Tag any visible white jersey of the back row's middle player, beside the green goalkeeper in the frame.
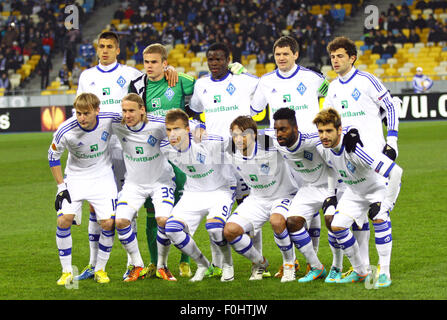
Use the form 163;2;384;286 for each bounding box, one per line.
190;72;259;137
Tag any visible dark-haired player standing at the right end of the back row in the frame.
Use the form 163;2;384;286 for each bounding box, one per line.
323;37;399;276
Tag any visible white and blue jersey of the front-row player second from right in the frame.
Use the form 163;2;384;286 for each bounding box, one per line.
265;129;330;187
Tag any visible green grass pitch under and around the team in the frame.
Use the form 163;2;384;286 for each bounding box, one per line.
0;122;447;301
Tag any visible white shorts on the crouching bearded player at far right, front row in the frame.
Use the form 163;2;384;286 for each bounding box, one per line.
332;188;388;228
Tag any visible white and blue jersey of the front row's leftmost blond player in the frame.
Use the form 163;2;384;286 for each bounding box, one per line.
48;112;119;178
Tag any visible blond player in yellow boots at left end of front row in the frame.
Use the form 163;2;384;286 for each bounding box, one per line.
48;93;118;285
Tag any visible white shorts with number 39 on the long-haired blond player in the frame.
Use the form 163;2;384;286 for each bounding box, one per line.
116;177;175;221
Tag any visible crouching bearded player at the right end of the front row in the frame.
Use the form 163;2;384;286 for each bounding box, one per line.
313;108;402;288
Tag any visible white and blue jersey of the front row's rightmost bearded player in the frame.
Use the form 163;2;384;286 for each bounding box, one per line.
319;136;396;202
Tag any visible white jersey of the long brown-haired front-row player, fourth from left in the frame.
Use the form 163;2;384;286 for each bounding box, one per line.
226;134;297;198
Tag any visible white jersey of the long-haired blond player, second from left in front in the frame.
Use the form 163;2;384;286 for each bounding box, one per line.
113;115;174;185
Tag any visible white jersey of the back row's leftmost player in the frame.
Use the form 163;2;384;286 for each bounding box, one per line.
77;62;142;113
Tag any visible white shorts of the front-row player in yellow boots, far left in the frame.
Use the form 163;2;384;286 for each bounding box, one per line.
57;170;117;225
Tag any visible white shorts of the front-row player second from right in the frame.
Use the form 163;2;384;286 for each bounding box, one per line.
287;186;331;226
